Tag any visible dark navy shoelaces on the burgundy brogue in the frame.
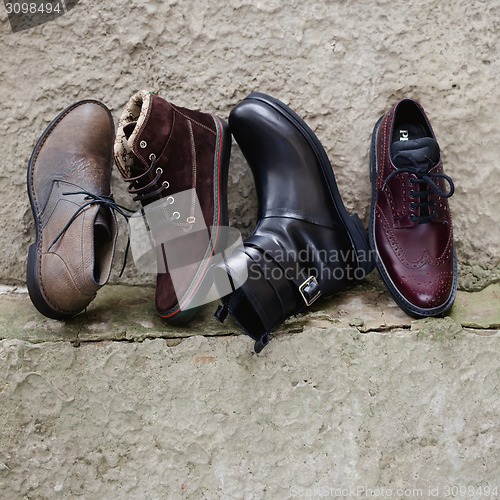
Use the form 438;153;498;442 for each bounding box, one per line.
382;152;455;224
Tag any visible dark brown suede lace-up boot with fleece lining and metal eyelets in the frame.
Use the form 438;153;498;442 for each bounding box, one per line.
114;91;231;324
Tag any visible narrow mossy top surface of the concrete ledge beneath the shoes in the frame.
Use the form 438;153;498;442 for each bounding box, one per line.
0;278;500;344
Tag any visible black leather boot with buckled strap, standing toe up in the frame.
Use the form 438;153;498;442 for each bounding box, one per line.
214;93;374;352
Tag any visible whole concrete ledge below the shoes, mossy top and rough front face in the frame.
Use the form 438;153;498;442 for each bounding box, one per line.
0;279;500;500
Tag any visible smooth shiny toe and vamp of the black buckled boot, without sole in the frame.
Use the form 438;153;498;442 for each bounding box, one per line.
229;94;338;223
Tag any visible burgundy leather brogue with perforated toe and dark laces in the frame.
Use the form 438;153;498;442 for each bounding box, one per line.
369;99;457;317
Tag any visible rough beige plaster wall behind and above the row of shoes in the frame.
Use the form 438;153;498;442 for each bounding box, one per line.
0;0;500;288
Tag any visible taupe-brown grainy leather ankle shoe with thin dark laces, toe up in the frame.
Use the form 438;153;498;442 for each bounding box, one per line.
27;100;117;319
